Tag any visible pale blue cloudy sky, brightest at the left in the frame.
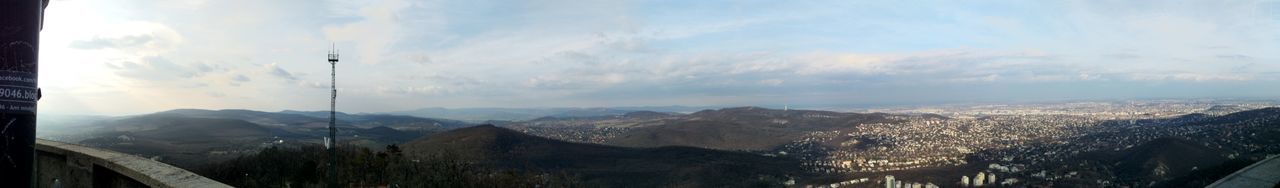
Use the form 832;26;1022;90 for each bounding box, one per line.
38;0;1280;115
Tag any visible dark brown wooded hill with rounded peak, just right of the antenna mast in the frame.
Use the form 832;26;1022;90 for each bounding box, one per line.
403;125;801;187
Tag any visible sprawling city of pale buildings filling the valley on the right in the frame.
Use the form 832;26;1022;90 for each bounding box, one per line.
783;102;1280;187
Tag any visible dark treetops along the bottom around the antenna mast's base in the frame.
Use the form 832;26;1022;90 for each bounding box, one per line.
193;145;582;188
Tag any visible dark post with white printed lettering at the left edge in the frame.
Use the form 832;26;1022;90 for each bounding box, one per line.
0;0;49;187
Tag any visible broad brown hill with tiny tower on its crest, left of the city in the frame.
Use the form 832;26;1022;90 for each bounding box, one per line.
605;107;893;151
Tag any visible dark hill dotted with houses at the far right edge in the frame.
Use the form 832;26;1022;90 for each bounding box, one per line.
1079;107;1280;187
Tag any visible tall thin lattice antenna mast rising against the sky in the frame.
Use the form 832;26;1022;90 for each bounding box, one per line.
325;45;338;188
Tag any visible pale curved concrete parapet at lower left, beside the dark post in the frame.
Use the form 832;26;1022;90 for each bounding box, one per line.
36;139;230;188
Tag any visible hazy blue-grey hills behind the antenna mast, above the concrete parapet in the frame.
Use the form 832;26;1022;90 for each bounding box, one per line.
59;109;473;168
